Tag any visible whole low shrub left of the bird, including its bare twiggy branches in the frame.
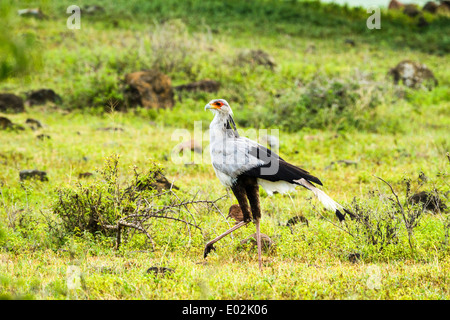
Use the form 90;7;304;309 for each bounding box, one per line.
52;156;212;249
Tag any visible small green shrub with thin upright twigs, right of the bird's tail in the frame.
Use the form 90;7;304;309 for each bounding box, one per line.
344;173;449;257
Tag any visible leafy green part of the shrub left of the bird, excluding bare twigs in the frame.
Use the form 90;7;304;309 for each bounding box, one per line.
52;156;161;236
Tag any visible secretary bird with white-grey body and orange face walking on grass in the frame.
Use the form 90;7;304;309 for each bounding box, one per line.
204;99;352;270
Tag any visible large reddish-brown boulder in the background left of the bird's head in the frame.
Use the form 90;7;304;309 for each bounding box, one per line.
124;70;175;109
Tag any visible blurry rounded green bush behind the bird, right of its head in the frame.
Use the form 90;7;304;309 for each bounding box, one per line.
243;79;382;131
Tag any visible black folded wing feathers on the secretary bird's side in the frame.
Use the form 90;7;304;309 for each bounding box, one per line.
242;145;322;185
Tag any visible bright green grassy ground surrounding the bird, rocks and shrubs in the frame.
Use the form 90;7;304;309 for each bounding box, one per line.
0;1;450;299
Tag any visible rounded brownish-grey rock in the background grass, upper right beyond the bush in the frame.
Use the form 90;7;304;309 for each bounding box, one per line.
388;60;438;90
